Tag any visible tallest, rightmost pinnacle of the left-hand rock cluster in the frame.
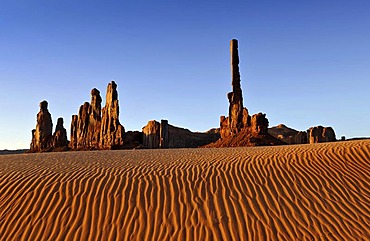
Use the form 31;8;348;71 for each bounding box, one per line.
99;81;125;149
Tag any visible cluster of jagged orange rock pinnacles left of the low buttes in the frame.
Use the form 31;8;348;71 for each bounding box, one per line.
30;81;125;152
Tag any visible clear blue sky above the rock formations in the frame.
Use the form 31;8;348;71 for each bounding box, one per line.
0;0;370;149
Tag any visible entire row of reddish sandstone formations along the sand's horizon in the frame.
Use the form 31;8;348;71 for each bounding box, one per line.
30;39;336;152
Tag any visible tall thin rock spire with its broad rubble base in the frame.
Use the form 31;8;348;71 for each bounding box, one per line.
208;39;284;147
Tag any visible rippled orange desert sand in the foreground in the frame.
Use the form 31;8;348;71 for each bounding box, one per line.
0;140;370;241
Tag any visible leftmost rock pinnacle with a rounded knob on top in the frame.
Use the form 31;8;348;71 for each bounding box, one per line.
30;100;53;152
